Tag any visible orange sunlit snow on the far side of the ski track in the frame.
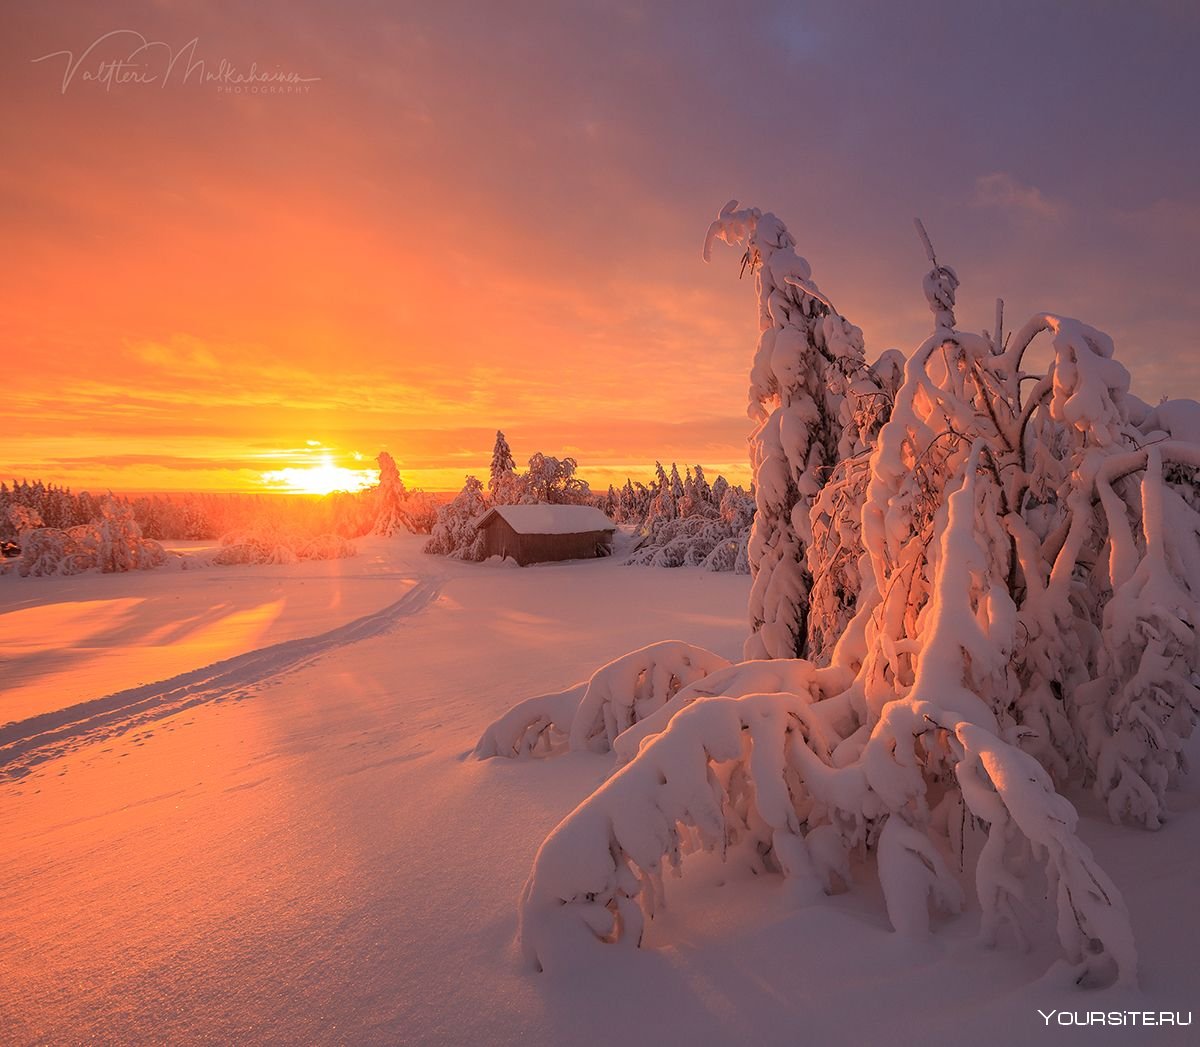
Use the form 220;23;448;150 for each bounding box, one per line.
0;542;428;724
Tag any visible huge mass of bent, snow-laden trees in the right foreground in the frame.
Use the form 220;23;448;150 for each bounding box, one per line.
480;204;1200;985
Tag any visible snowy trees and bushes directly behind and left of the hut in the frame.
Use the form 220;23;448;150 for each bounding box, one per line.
425;431;596;561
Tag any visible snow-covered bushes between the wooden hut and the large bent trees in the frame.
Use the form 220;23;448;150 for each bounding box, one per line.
616;462;755;574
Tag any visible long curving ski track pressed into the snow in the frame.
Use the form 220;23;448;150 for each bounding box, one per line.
0;576;445;782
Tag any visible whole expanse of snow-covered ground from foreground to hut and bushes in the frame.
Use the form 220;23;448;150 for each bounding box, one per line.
0;538;1200;1045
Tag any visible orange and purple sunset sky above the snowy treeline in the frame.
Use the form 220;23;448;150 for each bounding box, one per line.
0;0;1200;491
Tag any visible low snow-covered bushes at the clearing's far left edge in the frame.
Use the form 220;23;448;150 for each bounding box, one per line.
8;498;167;578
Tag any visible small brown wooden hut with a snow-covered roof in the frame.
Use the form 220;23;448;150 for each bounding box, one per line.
475;504;617;567
